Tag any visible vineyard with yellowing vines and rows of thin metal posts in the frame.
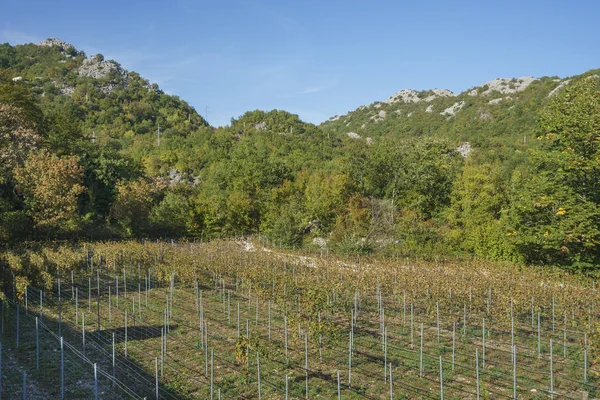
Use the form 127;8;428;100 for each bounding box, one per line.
0;239;600;399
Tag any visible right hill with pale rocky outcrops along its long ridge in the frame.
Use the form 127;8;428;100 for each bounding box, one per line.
320;70;600;155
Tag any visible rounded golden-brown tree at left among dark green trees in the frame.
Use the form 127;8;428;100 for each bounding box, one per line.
14;151;85;235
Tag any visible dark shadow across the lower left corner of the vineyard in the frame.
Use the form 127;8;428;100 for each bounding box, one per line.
0;294;185;399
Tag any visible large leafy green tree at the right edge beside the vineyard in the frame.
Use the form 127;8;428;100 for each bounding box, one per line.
507;79;600;268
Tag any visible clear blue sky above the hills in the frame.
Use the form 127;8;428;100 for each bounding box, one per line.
0;0;600;126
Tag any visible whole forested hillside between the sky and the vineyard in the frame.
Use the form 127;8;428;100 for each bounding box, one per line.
0;40;600;270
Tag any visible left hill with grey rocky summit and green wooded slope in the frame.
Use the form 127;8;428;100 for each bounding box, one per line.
0;38;208;153
